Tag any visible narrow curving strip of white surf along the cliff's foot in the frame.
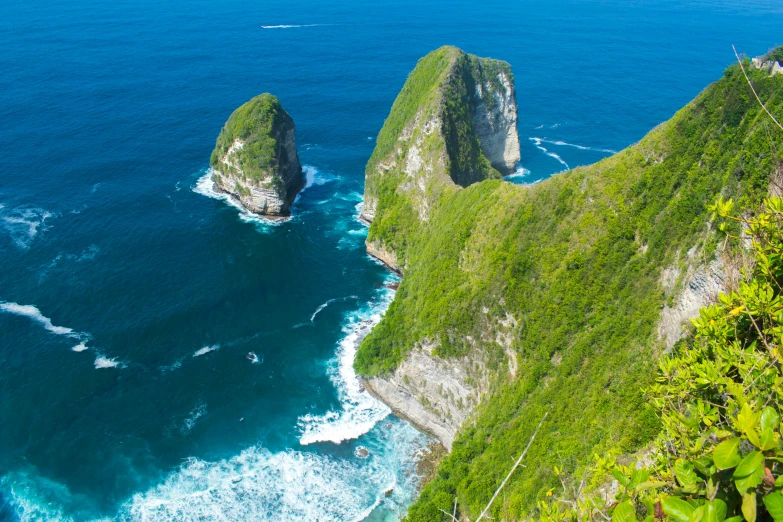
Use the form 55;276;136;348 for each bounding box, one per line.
299;276;396;445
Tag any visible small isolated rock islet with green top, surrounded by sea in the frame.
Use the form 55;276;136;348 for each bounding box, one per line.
209;93;305;219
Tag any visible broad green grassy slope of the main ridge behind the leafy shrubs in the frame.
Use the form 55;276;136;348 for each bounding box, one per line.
355;60;783;521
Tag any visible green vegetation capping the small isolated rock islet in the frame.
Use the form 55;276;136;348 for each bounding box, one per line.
209;93;293;182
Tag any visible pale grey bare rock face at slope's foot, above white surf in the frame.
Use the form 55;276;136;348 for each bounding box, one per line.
365;344;489;451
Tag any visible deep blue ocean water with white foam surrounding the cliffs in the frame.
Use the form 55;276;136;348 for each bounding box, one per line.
0;0;783;521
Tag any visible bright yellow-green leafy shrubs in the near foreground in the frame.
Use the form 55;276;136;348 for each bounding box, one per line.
541;198;783;522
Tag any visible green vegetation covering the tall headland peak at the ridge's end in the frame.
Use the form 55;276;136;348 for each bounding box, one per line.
365;46;511;266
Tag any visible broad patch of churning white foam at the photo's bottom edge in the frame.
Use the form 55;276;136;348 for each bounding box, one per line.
119;438;408;522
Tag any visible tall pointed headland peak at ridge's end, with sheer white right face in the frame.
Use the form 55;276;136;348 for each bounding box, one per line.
361;46;519;271
